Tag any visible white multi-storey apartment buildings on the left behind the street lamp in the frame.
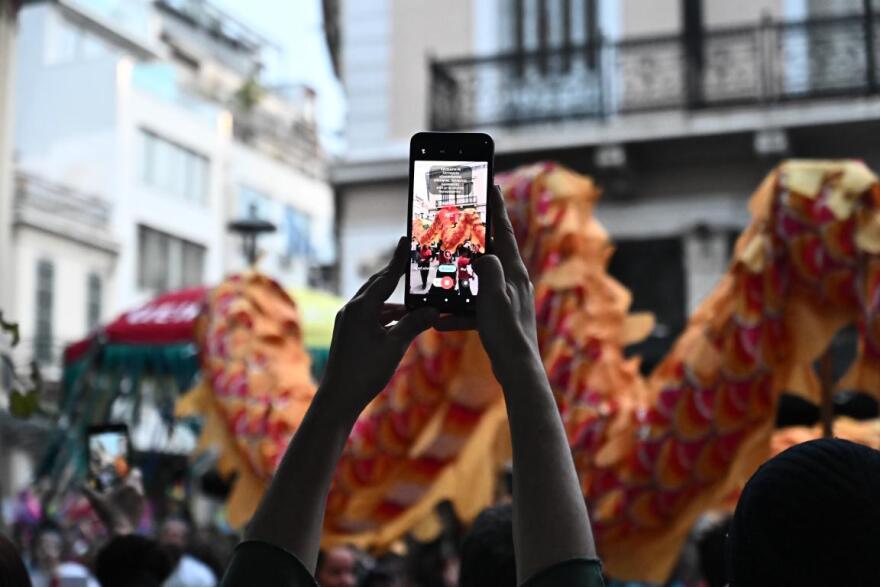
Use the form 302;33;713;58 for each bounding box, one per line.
8;0;334;366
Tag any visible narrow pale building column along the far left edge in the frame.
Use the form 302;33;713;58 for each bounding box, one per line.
0;0;18;317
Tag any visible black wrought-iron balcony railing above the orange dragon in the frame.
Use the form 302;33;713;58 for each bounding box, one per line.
430;14;880;130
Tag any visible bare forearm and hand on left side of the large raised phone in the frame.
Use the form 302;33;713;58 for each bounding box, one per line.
241;238;436;572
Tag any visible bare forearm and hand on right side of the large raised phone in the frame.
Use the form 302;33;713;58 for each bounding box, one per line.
437;187;596;582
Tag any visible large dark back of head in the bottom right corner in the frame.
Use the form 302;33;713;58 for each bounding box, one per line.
729;439;880;587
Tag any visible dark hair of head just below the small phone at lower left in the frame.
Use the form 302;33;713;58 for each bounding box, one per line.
95;534;174;587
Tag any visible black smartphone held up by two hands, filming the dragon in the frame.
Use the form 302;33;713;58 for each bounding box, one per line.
404;132;495;314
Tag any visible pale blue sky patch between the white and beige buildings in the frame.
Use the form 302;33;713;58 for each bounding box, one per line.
213;0;345;153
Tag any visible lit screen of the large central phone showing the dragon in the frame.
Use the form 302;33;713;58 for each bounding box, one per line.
409;160;489;308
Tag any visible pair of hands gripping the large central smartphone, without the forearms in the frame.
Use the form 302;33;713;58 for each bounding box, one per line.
318;186;540;419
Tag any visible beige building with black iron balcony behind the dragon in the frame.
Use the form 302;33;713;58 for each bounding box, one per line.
325;0;880;367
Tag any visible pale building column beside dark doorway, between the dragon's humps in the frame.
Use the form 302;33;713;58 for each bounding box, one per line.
684;227;729;318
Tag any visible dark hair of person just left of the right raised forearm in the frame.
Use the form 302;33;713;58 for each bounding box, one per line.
458;504;517;587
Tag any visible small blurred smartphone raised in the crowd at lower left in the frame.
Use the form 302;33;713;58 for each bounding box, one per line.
86;424;131;491
